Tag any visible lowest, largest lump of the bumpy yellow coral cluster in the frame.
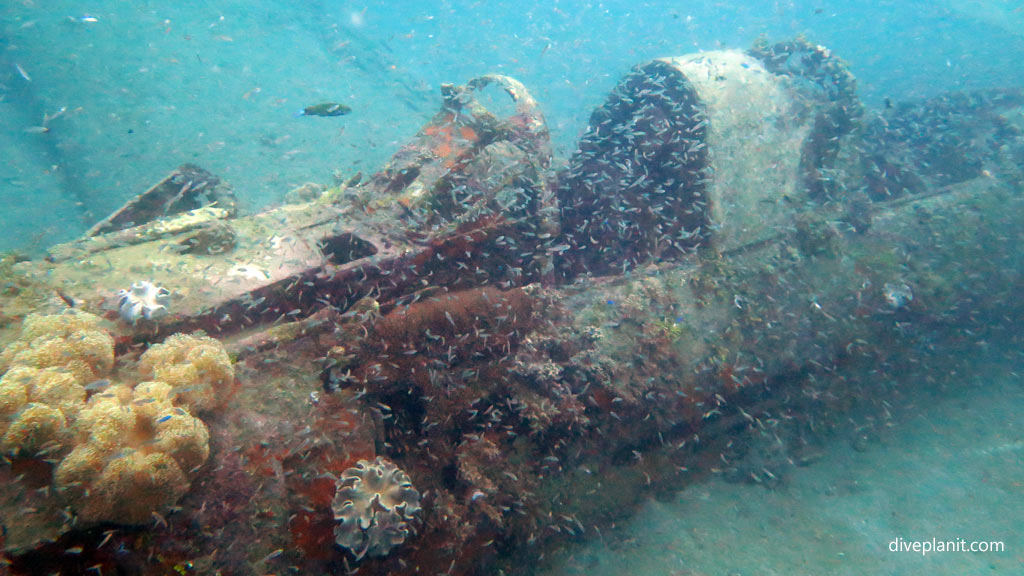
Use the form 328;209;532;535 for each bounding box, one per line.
54;382;210;524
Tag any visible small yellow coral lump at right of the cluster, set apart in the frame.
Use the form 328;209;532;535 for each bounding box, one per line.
138;334;234;412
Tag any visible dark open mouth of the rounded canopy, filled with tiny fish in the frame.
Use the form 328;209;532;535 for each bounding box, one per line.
557;60;708;277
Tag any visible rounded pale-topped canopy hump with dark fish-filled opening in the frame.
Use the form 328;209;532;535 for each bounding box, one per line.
557;44;859;278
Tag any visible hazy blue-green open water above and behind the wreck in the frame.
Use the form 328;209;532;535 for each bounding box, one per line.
0;0;1024;252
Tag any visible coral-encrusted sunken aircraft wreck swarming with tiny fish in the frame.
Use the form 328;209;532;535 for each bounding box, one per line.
0;40;1024;575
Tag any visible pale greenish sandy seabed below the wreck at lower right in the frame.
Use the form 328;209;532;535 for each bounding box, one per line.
544;356;1024;576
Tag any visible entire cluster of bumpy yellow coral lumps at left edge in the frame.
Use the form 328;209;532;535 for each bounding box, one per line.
0;312;234;524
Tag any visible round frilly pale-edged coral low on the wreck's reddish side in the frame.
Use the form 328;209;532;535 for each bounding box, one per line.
333;456;421;559
